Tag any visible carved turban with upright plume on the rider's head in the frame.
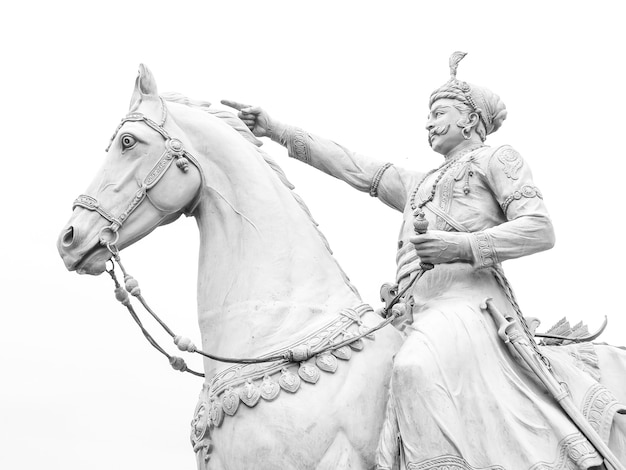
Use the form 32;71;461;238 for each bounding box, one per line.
429;52;506;135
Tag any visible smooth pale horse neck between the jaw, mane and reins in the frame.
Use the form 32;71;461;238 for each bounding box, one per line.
188;122;360;367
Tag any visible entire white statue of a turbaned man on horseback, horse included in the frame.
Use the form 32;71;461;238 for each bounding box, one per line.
57;56;626;470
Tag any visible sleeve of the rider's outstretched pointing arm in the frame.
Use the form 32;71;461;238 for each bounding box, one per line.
270;125;415;211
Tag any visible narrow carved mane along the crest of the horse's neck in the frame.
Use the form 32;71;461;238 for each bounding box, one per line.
161;92;360;297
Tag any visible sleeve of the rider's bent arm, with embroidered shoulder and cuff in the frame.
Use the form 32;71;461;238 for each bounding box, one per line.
470;145;554;267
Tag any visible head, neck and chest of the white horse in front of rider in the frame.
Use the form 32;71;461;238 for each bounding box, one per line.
58;66;401;470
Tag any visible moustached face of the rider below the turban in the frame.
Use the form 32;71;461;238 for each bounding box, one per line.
426;99;465;155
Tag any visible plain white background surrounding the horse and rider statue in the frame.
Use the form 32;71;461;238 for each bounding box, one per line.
0;0;626;470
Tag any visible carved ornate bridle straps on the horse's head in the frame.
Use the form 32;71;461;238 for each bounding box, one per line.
72;98;204;246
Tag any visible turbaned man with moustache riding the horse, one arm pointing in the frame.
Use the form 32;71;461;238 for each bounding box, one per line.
223;53;626;470
